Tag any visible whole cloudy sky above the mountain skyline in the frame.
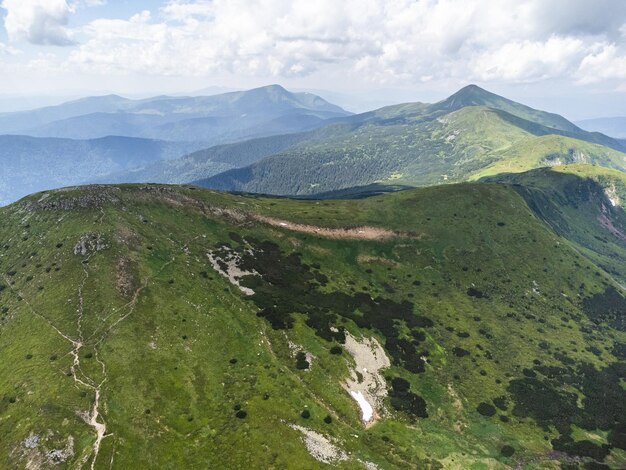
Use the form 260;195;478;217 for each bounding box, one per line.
0;0;626;119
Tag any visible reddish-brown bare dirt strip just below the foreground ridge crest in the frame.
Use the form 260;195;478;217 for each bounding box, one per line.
252;214;408;240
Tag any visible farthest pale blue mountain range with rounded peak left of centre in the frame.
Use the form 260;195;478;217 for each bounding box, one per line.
0;85;350;145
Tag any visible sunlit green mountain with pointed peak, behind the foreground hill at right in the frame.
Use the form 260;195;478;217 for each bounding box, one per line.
198;85;626;195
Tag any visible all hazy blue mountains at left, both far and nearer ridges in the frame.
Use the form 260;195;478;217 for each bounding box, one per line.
0;85;349;204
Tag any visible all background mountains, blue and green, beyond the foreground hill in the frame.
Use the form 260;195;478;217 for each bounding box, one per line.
0;85;626;203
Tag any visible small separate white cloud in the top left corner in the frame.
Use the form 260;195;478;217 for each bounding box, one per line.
0;0;74;46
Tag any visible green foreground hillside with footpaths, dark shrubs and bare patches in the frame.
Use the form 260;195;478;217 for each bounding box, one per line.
0;180;626;469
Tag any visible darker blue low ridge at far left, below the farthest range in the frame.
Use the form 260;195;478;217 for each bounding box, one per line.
0;135;204;205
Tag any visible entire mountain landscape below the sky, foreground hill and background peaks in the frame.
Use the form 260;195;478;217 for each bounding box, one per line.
0;82;626;470
